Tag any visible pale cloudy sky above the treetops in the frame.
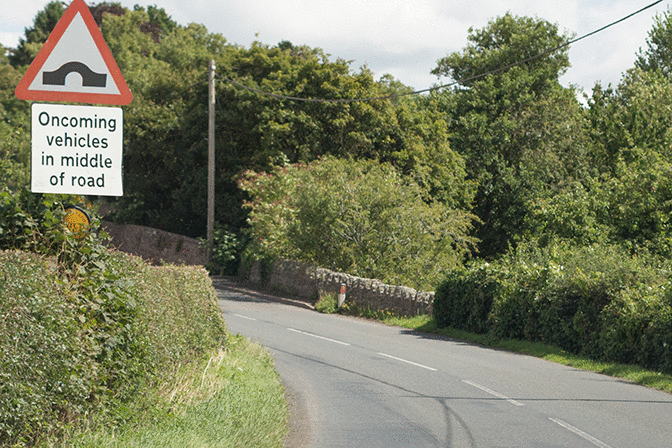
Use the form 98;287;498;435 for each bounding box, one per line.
0;0;672;94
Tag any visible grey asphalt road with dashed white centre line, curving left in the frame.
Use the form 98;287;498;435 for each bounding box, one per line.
215;280;672;448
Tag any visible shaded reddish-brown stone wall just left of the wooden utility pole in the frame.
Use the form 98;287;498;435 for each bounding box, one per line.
102;221;208;266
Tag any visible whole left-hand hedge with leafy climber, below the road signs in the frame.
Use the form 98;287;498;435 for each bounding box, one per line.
0;192;225;446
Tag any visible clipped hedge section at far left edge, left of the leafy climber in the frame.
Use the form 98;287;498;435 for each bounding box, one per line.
0;251;96;446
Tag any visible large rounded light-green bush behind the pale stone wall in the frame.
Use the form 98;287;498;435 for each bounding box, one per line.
241;158;474;288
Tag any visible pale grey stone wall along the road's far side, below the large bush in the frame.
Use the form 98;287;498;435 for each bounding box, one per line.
250;260;434;316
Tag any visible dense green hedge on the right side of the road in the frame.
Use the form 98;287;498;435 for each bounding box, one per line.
434;243;672;372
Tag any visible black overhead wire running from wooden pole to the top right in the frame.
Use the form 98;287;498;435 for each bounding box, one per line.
217;0;663;103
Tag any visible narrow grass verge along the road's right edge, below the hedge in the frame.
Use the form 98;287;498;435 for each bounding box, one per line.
338;303;672;393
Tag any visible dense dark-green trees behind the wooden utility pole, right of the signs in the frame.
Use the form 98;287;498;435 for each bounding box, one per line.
88;8;473;236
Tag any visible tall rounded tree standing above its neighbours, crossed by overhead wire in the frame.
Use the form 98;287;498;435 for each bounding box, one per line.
432;14;588;257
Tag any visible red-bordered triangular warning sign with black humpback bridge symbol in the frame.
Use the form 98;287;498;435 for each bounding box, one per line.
15;0;133;106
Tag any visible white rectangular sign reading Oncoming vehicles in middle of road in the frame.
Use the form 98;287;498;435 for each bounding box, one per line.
31;103;124;196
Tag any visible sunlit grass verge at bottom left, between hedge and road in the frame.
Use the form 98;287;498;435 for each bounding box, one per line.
63;335;288;448
